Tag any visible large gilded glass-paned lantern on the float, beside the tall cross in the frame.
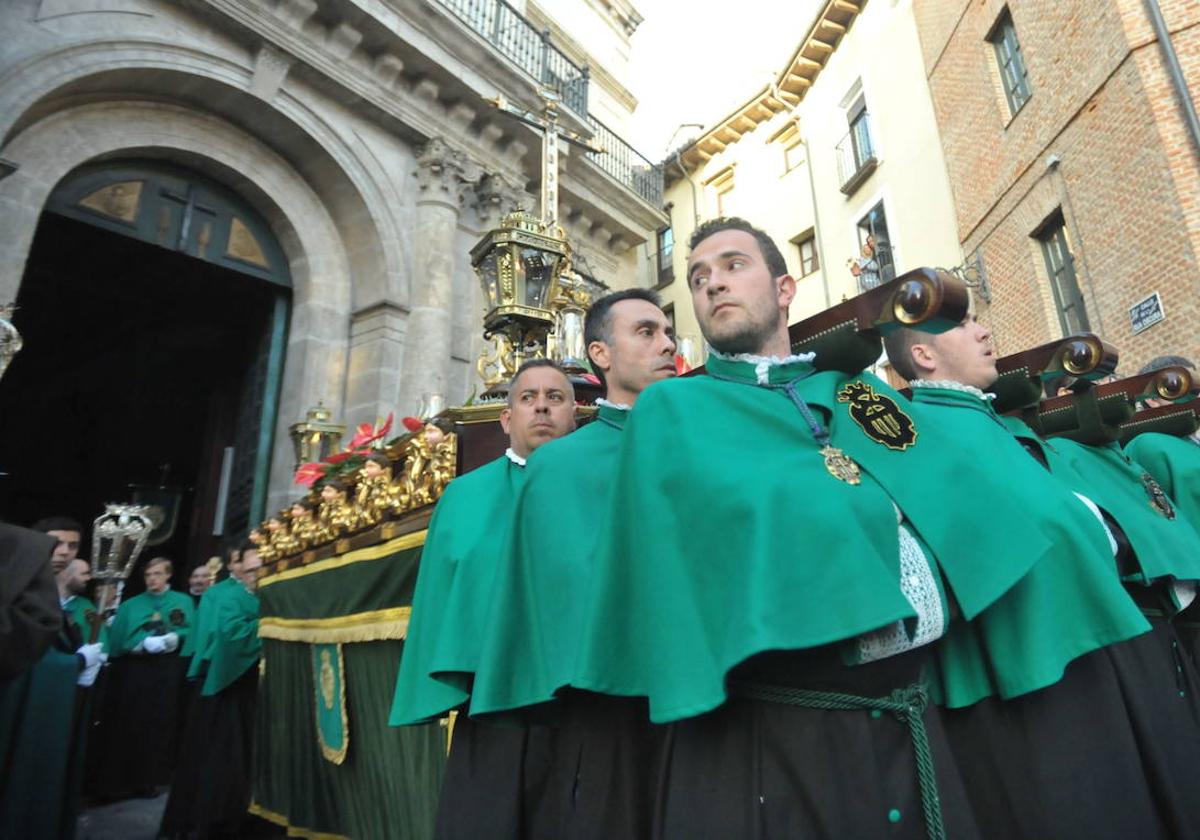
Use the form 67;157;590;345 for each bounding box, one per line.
470;210;570;384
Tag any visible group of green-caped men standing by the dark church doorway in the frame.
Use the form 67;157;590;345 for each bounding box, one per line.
0;517;272;840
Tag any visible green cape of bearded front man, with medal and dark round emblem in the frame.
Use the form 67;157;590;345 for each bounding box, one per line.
572;355;1032;722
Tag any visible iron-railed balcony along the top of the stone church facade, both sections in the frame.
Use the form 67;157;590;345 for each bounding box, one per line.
438;0;662;210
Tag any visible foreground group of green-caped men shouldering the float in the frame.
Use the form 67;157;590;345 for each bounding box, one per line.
390;218;1200;840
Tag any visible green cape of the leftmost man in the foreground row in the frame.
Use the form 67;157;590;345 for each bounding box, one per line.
388;455;524;726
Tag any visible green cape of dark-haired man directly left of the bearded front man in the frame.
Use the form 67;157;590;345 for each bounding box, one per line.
470;406;629;715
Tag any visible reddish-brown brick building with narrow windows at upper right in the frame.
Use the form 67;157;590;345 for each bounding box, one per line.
913;0;1200;374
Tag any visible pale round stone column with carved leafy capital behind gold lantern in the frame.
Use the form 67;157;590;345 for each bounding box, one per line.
400;139;482;412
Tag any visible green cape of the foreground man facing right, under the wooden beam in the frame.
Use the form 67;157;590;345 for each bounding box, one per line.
912;386;1150;708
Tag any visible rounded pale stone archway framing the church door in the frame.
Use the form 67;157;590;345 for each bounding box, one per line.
0;102;352;509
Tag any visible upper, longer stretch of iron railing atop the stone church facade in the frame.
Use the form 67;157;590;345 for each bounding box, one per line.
438;0;588;116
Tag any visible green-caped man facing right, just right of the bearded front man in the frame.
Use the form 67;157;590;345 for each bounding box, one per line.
886;316;1200;839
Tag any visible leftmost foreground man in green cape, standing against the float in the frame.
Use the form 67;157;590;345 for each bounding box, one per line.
389;359;575;840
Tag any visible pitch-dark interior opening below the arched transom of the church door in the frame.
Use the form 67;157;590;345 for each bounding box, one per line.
0;214;281;594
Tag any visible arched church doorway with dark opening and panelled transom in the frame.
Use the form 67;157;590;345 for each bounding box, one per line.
0;162;290;595
